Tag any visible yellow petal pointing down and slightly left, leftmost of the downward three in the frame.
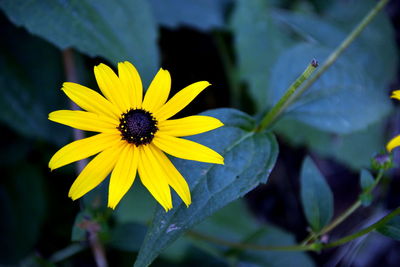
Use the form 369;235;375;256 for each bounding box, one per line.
108;144;139;209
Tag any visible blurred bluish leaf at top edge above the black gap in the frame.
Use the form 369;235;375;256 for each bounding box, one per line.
150;0;227;31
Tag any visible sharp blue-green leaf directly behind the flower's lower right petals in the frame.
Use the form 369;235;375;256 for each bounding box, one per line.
135;109;278;266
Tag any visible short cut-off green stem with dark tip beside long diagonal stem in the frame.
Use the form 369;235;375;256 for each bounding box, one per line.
256;59;318;131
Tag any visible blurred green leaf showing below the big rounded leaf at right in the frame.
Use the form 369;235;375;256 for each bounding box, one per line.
274;119;387;170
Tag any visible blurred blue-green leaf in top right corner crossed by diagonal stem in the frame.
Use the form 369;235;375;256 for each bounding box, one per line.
274;0;398;89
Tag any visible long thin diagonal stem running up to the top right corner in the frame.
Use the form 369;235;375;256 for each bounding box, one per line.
257;0;389;131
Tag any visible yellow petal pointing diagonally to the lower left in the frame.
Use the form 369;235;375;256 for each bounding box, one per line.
68;141;127;200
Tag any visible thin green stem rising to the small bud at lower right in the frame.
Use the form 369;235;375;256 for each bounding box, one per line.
302;169;385;244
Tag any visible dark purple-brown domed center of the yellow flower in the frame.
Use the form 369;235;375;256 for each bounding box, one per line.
117;109;158;146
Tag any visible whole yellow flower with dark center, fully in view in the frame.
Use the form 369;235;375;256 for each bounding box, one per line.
49;62;224;211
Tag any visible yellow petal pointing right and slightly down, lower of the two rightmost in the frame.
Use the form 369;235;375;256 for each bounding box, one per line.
153;134;224;164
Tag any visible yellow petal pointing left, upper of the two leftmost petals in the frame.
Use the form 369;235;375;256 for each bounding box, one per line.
49;110;119;133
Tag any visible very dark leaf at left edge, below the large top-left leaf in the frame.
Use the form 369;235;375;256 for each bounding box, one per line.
0;19;70;144
